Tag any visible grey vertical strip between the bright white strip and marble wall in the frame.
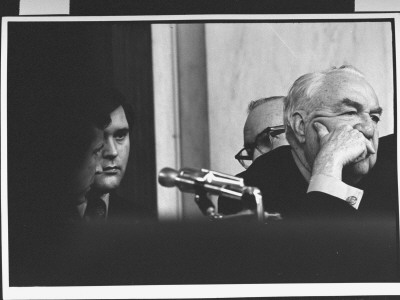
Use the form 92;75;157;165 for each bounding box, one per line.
176;24;210;220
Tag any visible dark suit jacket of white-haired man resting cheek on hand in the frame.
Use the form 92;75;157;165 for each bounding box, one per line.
218;135;398;220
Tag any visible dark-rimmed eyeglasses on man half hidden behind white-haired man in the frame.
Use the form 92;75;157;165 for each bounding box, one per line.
235;125;285;169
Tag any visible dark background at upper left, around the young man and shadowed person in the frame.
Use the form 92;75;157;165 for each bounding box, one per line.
8;22;157;215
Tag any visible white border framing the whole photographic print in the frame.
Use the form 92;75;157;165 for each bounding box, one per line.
1;13;400;299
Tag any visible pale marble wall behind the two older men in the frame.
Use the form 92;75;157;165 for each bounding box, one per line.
205;22;394;174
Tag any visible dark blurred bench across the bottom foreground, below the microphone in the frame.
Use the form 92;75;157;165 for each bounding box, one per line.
5;219;399;286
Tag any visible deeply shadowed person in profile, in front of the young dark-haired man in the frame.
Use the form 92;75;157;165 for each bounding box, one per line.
12;81;117;227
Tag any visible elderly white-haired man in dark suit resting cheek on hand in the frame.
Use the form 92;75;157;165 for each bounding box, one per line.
230;66;397;221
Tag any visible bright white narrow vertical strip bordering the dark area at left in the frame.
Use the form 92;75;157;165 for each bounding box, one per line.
151;24;182;221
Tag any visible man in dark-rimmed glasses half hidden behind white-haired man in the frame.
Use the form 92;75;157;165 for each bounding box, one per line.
218;96;288;214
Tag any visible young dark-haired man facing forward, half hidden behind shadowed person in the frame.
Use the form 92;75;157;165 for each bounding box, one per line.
84;89;143;221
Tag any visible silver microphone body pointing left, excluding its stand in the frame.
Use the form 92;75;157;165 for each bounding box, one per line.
158;168;246;200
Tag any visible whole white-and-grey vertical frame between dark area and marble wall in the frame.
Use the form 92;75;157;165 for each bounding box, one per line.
152;24;210;221
